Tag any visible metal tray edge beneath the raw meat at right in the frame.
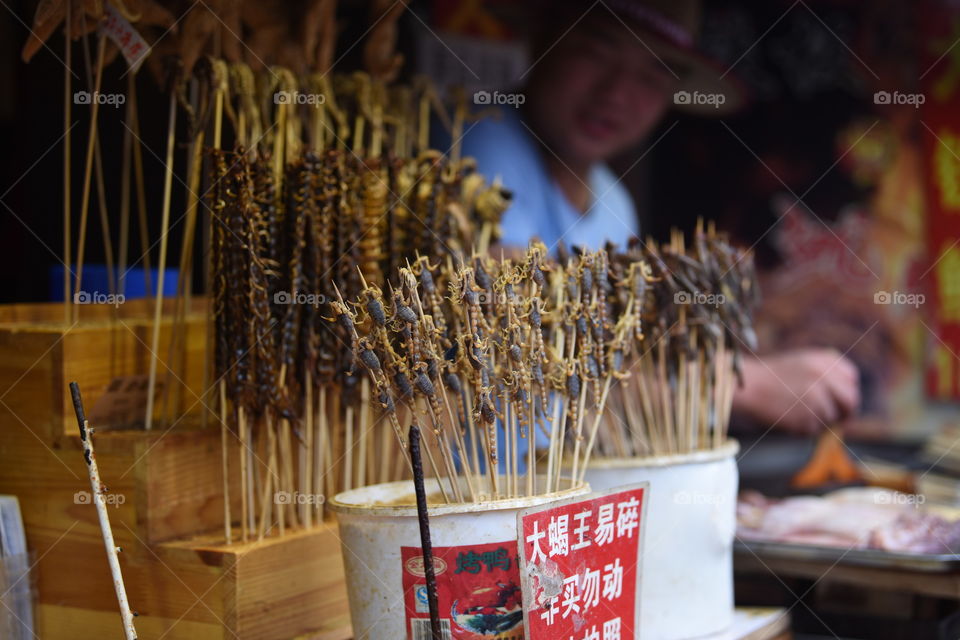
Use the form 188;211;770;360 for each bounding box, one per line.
733;539;960;573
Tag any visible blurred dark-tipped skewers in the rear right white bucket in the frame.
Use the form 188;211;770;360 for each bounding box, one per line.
597;223;759;458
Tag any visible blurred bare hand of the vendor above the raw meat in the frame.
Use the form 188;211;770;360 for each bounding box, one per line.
733;349;860;435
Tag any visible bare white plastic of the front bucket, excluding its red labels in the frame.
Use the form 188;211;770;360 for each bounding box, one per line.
330;479;590;640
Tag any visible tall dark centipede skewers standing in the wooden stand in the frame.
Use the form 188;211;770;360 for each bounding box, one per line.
208;67;510;539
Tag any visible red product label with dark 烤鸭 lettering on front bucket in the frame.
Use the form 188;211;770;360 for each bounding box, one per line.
400;540;523;640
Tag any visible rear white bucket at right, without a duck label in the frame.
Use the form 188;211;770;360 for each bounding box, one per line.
584;440;740;640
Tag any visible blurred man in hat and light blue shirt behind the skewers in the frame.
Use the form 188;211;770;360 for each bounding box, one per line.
454;0;860;434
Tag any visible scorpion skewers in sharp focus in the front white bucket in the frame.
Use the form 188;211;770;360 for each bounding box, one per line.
333;243;641;502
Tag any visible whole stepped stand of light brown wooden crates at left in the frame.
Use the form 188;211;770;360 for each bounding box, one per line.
0;305;351;640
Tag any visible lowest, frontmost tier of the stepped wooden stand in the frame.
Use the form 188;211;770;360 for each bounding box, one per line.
37;524;352;640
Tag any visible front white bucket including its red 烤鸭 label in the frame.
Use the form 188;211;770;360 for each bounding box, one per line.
330;479;590;640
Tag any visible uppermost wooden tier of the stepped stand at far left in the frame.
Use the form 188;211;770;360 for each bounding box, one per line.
0;299;213;443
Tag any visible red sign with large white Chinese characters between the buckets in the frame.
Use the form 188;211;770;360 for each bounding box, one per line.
517;487;645;640
